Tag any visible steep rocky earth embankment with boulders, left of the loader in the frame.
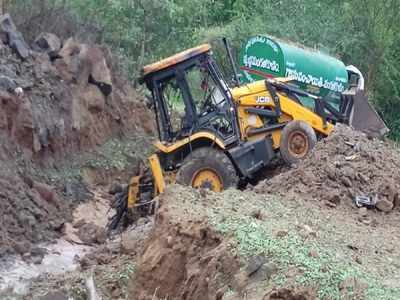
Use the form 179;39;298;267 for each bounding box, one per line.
0;15;153;255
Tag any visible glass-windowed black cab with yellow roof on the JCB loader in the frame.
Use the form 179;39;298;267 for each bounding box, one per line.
141;45;239;144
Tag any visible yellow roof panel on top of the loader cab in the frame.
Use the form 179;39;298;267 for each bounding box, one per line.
142;44;211;78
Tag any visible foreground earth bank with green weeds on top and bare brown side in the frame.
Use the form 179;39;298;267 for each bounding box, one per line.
128;186;400;300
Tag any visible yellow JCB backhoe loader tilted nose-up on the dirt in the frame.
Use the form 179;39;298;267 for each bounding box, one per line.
109;39;386;229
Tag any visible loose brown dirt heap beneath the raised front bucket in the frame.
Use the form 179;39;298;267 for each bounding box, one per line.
255;125;400;212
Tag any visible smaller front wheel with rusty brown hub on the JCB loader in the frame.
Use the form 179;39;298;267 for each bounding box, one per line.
280;120;317;164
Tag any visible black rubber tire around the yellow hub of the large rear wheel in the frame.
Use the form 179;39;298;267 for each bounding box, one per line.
176;147;239;190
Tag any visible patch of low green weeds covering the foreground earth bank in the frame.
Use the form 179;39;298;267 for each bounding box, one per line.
217;217;400;300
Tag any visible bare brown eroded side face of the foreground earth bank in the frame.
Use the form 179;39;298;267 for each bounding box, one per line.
129;190;239;299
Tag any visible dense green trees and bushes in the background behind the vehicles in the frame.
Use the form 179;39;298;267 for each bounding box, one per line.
6;0;400;139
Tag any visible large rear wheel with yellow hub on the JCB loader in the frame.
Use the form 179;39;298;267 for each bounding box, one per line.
176;147;239;192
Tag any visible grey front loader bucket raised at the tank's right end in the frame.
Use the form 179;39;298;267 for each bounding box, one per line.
349;91;389;137
